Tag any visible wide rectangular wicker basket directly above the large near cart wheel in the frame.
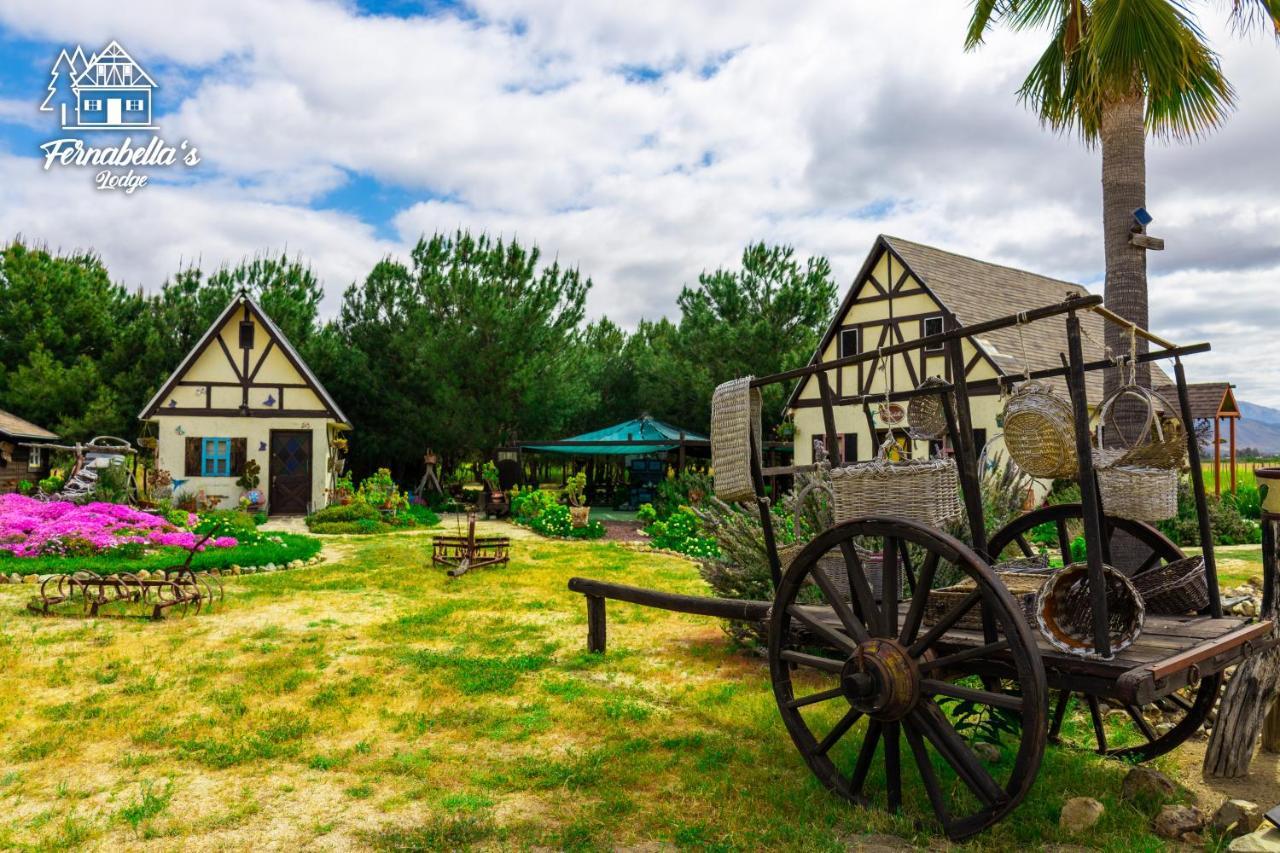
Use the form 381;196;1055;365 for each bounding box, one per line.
831;459;960;528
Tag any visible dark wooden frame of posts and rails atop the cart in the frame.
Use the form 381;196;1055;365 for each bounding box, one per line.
750;296;1222;657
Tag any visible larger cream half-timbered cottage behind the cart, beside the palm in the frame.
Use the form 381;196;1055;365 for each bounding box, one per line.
787;236;1170;481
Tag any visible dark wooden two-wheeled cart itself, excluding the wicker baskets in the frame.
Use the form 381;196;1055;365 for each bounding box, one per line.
570;296;1272;839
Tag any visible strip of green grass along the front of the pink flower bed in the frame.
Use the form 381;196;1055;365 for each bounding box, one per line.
0;533;320;575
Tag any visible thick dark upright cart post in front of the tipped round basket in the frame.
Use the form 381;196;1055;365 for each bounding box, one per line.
1066;311;1111;657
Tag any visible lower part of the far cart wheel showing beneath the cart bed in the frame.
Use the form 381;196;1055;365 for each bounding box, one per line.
1048;672;1222;762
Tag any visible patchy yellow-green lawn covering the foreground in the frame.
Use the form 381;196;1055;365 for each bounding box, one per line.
0;530;1198;850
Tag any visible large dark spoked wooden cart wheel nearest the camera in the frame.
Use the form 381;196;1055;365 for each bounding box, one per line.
769;517;1047;839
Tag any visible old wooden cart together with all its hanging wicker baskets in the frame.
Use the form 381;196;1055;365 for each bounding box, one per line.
570;296;1274;839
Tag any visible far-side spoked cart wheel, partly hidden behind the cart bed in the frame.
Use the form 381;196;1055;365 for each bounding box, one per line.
991;503;1222;761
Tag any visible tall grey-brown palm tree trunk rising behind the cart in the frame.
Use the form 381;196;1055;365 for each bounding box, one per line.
1101;92;1151;402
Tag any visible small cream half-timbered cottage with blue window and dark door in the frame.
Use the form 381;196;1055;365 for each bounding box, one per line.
138;292;351;515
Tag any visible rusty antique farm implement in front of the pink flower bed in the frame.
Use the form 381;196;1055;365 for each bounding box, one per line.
28;566;223;620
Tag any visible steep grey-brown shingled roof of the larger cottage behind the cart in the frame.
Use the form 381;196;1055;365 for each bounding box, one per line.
787;234;1171;406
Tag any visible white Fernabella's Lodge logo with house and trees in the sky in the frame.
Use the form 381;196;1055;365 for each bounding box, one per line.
40;41;200;195
